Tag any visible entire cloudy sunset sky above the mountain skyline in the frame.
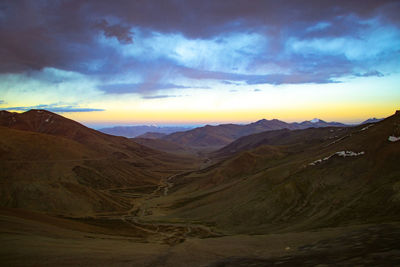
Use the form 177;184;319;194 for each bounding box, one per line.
0;0;400;127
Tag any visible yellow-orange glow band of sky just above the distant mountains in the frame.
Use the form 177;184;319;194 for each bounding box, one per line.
57;104;399;125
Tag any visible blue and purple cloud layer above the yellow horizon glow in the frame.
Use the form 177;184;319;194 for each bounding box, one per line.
0;0;400;115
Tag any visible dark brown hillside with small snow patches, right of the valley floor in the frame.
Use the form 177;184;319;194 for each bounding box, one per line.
139;112;400;233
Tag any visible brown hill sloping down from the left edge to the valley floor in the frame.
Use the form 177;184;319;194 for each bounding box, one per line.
0;110;195;216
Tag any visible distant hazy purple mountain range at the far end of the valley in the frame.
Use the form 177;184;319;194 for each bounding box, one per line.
100;118;379;153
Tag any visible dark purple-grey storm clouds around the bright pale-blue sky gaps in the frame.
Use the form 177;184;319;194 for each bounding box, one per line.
0;0;400;91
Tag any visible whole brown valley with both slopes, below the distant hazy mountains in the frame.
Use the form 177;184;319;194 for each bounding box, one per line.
0;111;400;266
